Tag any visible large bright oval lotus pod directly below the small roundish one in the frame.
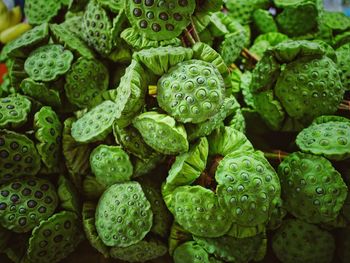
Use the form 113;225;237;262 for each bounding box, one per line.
96;182;153;247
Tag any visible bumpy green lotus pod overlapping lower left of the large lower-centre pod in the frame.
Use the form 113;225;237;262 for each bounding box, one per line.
173;186;232;237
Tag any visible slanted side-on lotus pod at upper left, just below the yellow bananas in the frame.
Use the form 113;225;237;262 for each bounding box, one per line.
1;23;49;57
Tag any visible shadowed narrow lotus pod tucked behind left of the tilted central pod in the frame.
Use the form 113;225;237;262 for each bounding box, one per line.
113;123;154;160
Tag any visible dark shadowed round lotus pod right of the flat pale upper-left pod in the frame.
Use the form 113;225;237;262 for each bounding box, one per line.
64;57;109;108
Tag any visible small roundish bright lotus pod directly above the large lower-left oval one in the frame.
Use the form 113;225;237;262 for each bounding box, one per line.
90;145;133;186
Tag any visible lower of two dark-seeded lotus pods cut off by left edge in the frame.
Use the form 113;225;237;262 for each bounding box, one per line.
0;177;58;233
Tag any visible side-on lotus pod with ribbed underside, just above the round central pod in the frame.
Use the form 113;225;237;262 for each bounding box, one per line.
134;46;193;76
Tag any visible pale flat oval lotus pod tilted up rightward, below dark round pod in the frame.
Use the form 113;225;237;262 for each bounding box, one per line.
72;100;120;143
